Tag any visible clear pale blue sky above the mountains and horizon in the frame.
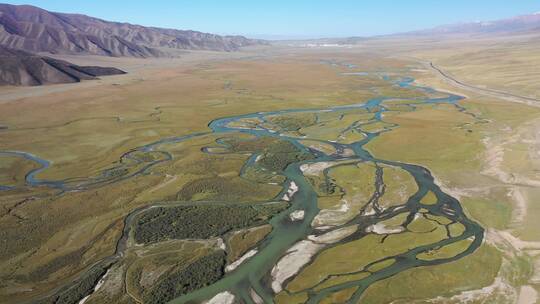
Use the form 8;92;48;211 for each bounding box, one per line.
6;0;540;38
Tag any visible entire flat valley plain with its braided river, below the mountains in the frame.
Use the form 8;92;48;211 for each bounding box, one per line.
0;32;540;304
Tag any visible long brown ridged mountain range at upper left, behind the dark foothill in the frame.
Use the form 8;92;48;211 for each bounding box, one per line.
0;4;262;57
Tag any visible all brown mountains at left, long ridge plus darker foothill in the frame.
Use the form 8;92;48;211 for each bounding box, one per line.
0;3;265;85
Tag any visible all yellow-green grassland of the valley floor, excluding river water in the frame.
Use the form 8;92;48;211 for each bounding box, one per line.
0;38;540;304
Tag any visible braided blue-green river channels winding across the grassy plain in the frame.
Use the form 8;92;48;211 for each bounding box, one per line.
0;73;484;303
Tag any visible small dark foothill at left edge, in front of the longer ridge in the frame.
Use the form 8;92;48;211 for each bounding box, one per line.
0;46;125;85
